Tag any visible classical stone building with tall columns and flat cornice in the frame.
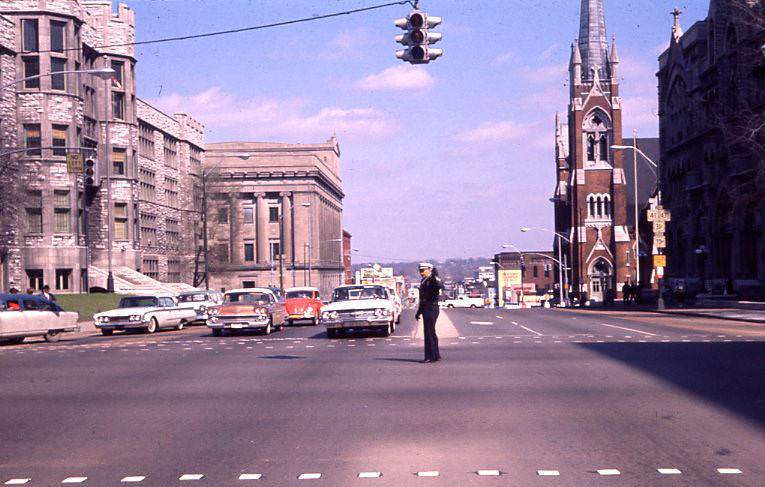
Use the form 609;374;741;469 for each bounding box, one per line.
205;137;344;296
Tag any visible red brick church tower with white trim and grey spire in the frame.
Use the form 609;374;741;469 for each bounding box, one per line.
554;0;634;302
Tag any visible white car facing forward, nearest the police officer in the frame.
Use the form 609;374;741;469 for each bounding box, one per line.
321;284;396;338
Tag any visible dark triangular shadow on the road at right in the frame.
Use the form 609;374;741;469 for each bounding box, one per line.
577;342;765;425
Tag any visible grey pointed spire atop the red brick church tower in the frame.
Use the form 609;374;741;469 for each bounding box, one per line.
579;0;609;79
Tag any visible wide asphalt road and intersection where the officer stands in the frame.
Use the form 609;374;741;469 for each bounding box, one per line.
0;309;765;487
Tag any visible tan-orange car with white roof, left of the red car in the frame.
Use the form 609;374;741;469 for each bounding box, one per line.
207;287;287;336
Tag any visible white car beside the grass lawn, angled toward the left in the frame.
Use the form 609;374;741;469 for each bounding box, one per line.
93;295;197;336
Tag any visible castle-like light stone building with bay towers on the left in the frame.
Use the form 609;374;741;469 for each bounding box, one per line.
0;0;204;292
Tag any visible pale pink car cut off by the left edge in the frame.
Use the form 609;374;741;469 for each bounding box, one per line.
0;294;80;345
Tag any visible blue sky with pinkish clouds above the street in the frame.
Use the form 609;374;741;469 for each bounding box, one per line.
128;0;708;260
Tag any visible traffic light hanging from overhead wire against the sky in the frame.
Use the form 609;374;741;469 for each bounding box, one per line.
394;10;444;64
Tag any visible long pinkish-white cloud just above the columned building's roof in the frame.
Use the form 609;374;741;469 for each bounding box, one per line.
150;87;398;141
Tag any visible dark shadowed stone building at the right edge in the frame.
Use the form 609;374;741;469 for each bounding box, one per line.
658;0;765;299
